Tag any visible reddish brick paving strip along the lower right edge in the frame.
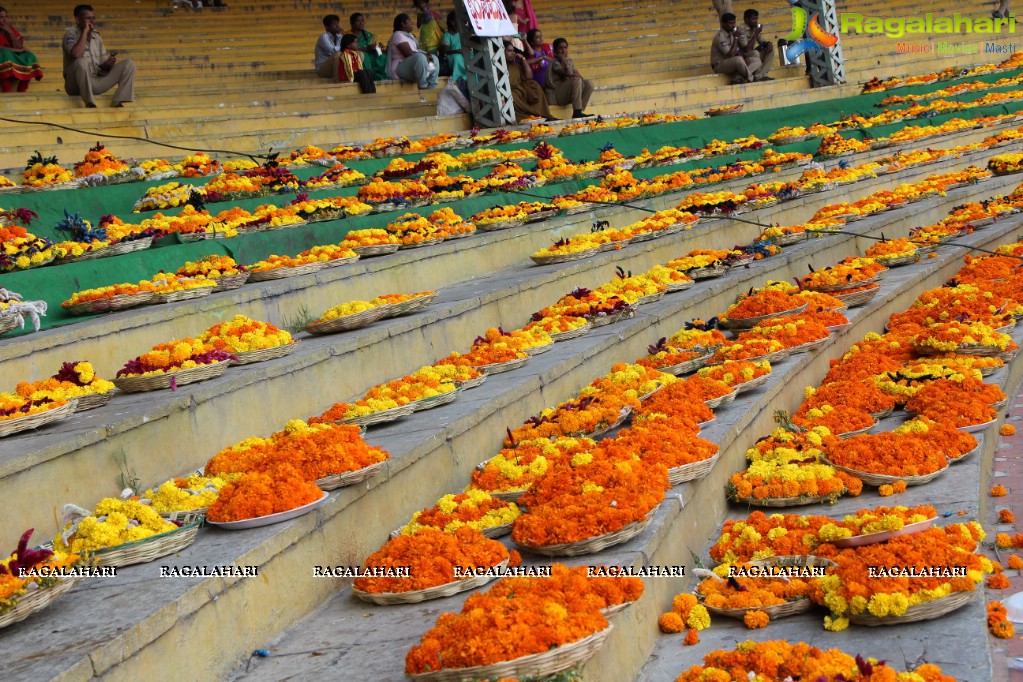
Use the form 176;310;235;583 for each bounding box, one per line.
981;387;1023;682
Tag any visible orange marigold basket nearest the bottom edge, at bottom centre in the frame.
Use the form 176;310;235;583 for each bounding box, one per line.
405;578;612;682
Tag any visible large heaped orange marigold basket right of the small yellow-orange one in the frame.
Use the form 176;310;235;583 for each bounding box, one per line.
512;444;670;556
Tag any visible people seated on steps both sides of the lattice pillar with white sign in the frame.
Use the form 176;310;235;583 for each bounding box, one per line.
313;0;593;120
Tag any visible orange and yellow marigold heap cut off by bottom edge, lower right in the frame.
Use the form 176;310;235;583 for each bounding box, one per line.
677;640;952;682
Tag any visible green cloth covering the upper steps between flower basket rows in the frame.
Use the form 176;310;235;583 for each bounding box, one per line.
6;67;1023;335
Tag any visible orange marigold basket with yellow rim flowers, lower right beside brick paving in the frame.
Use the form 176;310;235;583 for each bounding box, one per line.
810;521;992;631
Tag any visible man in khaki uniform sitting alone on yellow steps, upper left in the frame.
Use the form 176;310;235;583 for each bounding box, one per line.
63;5;135;108
